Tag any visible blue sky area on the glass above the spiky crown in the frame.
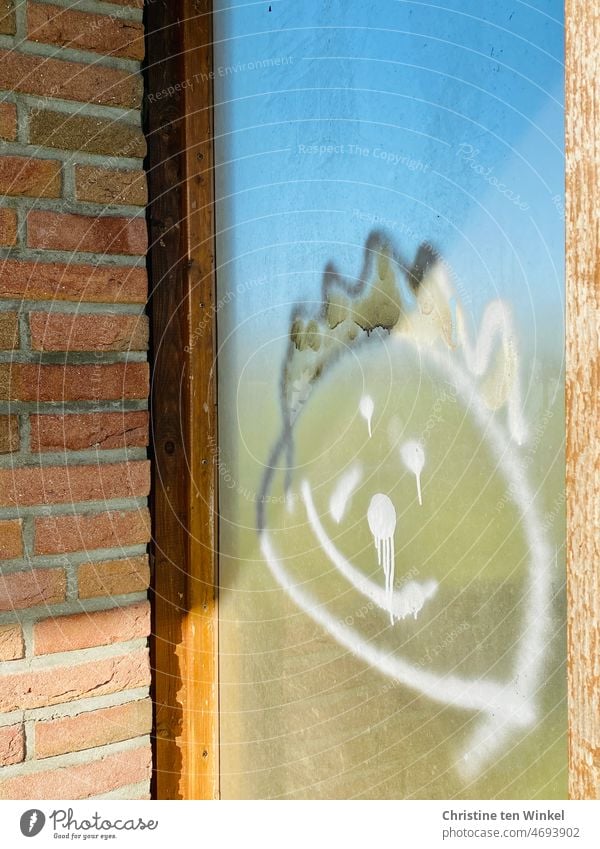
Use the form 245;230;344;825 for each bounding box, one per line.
215;0;564;350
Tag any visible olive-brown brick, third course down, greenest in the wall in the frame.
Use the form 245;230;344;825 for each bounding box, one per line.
29;110;146;159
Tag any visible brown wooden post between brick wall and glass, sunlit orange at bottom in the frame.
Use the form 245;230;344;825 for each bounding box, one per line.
146;0;219;799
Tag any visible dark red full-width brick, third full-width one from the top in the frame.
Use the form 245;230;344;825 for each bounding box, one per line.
0;363;148;401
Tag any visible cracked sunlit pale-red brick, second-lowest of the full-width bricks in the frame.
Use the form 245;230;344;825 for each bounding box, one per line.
0;649;150;713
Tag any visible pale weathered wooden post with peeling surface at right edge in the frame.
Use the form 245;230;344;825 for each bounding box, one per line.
566;0;600;799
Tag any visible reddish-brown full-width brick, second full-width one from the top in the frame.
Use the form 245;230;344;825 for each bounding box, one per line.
0;260;148;304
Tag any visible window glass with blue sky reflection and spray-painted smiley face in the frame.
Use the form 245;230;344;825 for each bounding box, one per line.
214;0;567;799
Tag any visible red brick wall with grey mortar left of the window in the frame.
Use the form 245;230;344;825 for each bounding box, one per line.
0;0;151;799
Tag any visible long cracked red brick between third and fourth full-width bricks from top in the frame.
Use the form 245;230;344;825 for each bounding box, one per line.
31;411;148;451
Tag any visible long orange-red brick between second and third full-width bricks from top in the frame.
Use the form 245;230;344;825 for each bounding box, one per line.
29;312;148;351
